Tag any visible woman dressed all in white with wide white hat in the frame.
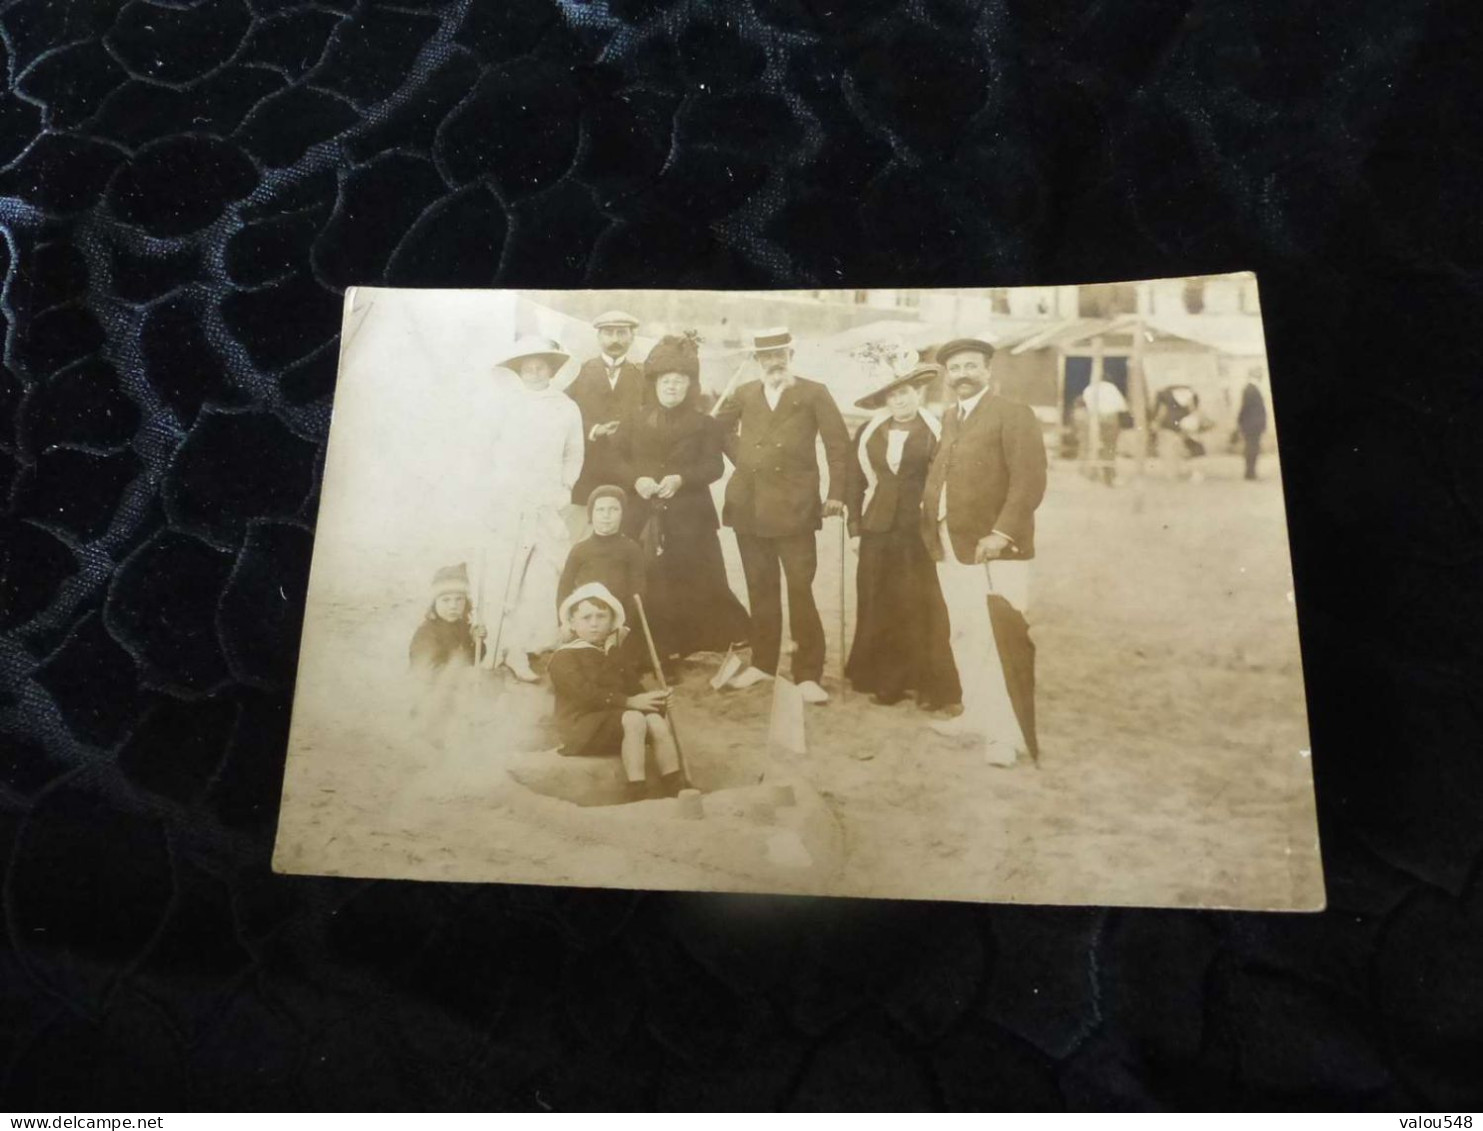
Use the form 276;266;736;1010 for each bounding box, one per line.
479;338;583;682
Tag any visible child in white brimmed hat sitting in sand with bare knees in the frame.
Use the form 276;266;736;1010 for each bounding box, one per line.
547;581;681;800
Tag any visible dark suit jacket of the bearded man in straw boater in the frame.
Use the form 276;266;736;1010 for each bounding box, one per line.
718;377;850;538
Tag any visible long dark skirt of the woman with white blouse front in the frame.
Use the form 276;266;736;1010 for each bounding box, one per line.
845;523;962;706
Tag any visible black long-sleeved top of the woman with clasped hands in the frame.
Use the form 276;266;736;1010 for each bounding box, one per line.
614;403;725;537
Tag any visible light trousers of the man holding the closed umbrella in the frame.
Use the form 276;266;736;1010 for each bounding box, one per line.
937;522;1031;762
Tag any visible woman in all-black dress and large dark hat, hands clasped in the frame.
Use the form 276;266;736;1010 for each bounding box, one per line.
615;335;749;664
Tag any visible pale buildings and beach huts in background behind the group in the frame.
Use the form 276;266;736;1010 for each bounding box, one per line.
516;273;1266;428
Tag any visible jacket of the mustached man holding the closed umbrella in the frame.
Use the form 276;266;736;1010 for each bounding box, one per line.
922;393;1046;563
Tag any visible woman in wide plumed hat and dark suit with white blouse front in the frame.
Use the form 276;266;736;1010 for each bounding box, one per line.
845;365;962;710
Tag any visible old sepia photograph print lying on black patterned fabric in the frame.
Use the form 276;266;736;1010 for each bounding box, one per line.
274;281;1324;910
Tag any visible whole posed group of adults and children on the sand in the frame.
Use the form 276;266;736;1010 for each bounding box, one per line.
411;311;1046;795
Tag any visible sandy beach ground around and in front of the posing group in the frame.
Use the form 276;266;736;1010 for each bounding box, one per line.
274;457;1323;909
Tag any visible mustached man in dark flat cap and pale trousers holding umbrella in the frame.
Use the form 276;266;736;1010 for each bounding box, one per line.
922;338;1046;766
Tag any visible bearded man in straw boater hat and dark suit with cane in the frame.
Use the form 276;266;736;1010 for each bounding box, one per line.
716;328;850;703
